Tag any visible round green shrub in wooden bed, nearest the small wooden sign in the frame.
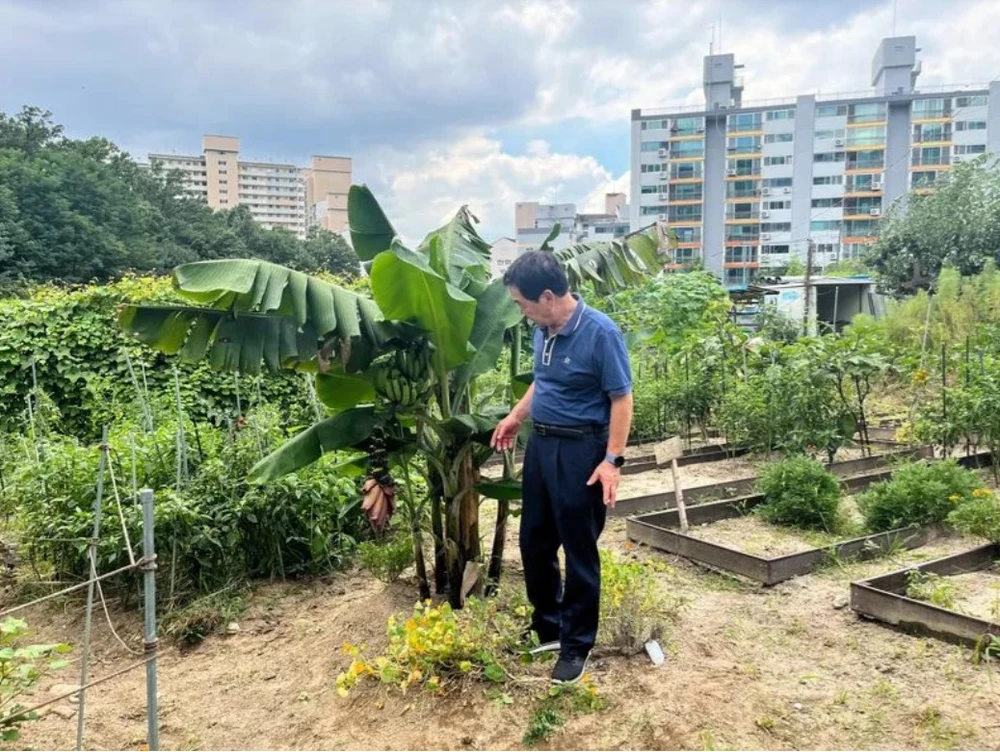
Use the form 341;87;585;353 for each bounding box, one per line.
756;456;840;532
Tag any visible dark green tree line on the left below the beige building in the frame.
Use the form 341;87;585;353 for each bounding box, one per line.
0;106;359;289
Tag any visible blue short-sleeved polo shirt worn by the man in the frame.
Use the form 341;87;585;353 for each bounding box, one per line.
531;293;632;426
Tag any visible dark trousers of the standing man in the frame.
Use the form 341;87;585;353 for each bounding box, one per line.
520;432;607;655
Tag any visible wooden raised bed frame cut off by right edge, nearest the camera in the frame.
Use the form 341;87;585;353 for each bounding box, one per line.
851;543;1000;645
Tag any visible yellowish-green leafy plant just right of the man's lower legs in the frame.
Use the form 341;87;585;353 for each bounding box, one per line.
597;551;684;655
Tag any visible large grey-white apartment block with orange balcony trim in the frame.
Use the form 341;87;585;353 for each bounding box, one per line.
630;36;1000;288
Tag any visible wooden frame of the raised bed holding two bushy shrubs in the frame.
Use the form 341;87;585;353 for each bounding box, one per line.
625;452;989;585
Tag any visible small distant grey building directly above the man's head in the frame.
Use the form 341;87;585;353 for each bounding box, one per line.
514;193;629;253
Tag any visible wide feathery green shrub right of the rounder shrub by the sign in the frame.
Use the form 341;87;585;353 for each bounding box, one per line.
858;459;982;533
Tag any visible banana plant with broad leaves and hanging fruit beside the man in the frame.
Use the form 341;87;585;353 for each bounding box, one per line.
120;186;660;606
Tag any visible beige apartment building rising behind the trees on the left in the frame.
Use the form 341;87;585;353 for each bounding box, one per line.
149;135;351;238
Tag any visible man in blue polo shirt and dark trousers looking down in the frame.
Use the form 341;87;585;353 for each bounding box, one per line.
492;251;632;683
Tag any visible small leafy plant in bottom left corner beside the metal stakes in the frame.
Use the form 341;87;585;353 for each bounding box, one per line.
0;616;70;742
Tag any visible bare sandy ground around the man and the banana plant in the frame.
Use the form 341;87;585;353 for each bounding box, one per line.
7;452;1000;749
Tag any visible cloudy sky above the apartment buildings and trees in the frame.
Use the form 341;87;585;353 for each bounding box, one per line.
0;0;1000;239
